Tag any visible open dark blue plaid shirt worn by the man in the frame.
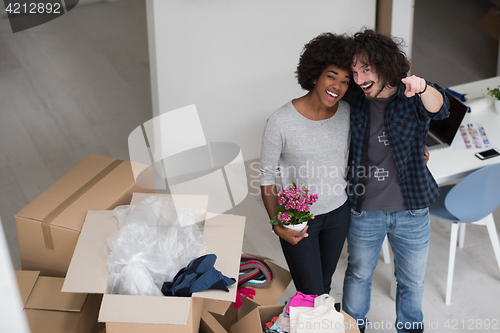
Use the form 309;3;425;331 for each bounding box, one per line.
347;82;449;212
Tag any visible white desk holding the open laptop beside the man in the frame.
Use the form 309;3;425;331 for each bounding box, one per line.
427;76;500;184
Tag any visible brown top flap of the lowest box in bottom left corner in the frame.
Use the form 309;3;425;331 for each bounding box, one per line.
25;276;87;312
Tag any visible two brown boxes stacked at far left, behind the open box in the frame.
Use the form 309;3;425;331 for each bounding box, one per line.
15;155;153;333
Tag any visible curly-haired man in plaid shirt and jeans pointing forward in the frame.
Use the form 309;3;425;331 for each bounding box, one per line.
342;30;449;333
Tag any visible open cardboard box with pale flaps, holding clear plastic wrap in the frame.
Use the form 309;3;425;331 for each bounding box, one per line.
62;195;245;333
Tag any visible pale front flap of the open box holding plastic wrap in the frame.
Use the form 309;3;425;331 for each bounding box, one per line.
99;294;192;325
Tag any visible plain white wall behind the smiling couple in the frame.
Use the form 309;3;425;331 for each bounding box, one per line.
147;0;376;160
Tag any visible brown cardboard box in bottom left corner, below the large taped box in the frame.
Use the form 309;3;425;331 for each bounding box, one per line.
15;271;103;333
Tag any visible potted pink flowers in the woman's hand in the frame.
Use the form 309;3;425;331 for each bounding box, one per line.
270;181;318;231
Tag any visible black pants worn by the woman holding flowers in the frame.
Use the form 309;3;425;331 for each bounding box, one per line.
280;200;351;295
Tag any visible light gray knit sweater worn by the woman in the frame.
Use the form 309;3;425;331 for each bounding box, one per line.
260;101;350;215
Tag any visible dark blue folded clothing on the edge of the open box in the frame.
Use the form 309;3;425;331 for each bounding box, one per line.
161;254;236;297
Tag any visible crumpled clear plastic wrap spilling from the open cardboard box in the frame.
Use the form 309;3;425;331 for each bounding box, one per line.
107;196;206;296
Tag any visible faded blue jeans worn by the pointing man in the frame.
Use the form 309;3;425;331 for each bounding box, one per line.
342;208;430;333
